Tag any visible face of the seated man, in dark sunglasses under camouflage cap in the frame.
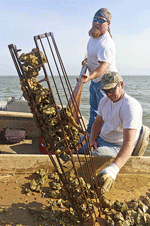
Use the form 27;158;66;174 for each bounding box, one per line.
103;82;124;102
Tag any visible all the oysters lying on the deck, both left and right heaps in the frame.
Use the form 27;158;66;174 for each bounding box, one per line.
25;170;150;226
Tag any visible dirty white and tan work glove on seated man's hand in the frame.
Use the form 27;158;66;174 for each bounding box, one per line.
97;163;119;195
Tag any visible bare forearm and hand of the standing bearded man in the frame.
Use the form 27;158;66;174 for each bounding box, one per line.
82;62;110;83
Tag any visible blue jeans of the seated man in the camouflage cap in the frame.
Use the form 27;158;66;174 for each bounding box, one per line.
78;135;121;157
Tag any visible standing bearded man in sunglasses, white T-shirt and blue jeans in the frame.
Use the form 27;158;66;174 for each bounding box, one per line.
82;8;117;133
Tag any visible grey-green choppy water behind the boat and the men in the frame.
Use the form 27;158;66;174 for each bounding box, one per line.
0;76;150;155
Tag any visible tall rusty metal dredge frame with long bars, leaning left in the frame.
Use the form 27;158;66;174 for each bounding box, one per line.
8;32;101;225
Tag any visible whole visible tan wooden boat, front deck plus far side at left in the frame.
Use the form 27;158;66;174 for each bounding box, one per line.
0;109;150;226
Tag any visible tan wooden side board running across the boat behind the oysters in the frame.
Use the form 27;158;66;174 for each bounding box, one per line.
0;154;150;177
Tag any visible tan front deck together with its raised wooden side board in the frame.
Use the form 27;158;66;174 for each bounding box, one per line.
0;154;150;226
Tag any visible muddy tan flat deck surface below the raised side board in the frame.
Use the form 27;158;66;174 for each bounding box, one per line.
0;170;150;226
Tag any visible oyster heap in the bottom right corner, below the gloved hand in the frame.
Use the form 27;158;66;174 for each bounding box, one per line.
103;196;150;226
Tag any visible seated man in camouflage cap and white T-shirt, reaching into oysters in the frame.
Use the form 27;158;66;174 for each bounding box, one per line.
78;72;142;194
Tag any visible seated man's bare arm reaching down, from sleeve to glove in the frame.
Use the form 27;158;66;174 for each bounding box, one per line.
113;129;137;169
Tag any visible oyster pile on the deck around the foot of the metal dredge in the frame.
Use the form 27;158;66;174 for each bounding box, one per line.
25;169;96;226
